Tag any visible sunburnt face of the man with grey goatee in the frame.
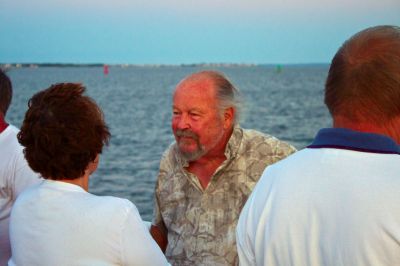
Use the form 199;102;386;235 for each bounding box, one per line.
172;80;225;161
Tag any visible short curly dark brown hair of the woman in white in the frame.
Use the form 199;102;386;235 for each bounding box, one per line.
18;83;110;180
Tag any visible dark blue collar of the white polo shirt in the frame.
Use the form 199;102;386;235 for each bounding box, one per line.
307;128;400;154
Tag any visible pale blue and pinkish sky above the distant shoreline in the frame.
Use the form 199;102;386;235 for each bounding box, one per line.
0;0;400;64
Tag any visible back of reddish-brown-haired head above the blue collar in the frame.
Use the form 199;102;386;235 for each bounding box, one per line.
325;26;400;126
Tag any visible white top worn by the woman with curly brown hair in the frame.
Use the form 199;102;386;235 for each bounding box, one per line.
9;180;168;266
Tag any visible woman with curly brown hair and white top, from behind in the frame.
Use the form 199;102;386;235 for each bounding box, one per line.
9;83;168;266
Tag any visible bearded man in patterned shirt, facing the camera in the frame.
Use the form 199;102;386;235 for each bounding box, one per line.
151;71;295;265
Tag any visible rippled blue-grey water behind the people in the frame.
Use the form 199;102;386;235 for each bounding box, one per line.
7;65;330;220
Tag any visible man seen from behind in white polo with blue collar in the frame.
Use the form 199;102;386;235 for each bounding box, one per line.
237;26;400;266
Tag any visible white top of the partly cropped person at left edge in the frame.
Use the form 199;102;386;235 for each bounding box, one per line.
0;125;40;266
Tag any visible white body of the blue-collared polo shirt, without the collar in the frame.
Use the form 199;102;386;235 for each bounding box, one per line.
236;128;400;266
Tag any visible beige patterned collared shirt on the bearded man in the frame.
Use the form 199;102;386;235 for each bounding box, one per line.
153;127;296;266
